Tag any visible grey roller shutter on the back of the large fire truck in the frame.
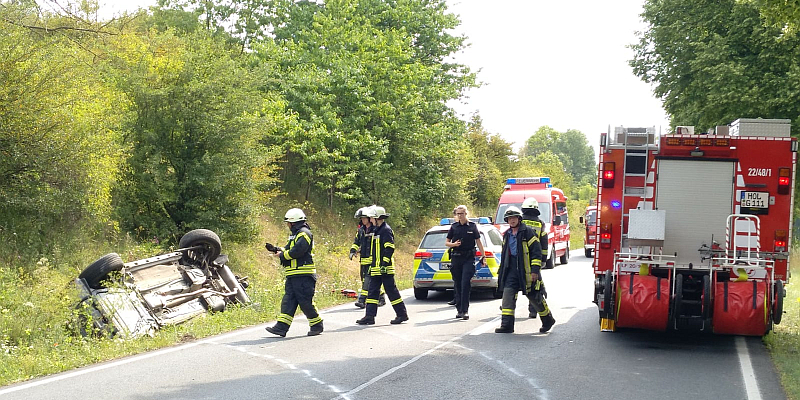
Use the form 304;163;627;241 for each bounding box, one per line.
656;159;735;265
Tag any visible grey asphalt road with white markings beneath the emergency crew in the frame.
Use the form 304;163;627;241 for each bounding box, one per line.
0;251;786;400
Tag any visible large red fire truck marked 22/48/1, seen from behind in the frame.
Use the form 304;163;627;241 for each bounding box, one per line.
593;119;797;336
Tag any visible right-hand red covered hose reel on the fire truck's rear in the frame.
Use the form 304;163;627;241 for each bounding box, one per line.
712;279;769;336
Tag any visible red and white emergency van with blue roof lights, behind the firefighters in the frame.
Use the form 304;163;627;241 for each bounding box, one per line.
495;176;570;268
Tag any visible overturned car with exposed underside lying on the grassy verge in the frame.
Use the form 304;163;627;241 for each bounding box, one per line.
75;229;250;338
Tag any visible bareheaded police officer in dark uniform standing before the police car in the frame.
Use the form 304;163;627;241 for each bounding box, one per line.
444;205;486;319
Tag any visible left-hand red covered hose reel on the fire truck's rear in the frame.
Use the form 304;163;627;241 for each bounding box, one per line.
617;273;670;331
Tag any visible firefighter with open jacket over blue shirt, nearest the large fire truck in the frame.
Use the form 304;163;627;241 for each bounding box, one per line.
494;206;556;333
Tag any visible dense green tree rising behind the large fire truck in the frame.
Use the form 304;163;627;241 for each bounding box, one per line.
630;0;800;131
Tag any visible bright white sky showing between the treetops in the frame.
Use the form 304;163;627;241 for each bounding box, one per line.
101;0;669;152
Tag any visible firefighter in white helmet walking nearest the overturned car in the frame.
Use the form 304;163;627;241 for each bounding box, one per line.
266;208;322;337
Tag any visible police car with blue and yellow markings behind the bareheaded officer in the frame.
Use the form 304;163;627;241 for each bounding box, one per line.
414;217;503;300
